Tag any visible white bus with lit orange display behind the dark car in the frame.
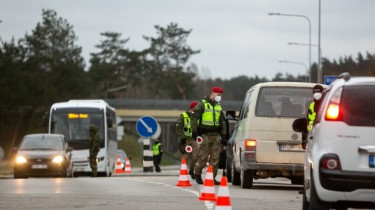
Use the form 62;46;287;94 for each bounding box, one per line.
48;100;117;176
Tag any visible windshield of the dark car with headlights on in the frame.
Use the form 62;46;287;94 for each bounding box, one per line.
20;136;64;150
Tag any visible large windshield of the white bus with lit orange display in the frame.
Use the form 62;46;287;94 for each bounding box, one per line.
51;108;104;149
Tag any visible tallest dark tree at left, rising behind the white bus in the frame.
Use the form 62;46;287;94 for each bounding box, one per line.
24;10;89;105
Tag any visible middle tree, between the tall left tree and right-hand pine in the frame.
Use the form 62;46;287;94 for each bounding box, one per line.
89;32;144;98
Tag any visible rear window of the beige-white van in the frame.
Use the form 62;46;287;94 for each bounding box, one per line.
255;87;313;118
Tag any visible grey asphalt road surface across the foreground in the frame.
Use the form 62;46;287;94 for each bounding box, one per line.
0;168;302;210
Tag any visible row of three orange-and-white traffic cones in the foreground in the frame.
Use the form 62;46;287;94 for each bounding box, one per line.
176;158;232;210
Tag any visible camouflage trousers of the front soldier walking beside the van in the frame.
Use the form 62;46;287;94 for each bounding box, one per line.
194;134;221;178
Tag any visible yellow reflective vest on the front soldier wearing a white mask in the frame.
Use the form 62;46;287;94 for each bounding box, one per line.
201;99;223;126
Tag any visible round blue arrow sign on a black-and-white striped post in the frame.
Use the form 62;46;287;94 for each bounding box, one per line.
136;116;160;172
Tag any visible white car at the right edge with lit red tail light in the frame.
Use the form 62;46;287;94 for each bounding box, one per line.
293;73;375;210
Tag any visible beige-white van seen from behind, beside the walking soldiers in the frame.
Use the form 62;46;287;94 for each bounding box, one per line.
230;82;315;188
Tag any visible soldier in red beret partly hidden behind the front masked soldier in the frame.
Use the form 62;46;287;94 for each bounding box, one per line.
176;101;198;179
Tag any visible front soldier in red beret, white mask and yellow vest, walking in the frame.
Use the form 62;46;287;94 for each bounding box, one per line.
191;87;226;185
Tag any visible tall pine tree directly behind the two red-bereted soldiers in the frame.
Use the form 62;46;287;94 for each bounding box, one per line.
144;23;200;100
